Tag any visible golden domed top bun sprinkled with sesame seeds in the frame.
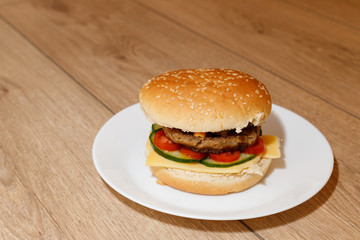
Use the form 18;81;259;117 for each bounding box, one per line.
140;68;271;132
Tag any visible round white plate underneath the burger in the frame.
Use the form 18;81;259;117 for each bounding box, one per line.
93;104;334;220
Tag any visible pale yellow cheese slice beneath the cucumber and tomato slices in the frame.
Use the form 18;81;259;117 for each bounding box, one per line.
146;136;280;174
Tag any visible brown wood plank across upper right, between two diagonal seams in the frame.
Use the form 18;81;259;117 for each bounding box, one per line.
134;0;360;117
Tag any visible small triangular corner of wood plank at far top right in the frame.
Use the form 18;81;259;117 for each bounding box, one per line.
285;0;360;30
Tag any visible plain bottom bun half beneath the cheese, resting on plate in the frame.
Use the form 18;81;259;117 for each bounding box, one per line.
150;159;271;195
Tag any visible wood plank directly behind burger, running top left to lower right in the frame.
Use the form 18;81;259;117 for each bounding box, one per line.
2;1;360;239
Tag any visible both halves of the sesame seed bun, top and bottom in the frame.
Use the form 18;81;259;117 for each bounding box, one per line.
139;69;271;195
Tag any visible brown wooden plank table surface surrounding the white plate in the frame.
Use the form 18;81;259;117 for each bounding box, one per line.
0;0;360;239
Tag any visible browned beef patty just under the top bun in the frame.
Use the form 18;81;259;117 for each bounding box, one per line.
163;124;261;154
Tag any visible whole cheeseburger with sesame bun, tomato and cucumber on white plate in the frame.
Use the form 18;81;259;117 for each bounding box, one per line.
139;69;280;195
